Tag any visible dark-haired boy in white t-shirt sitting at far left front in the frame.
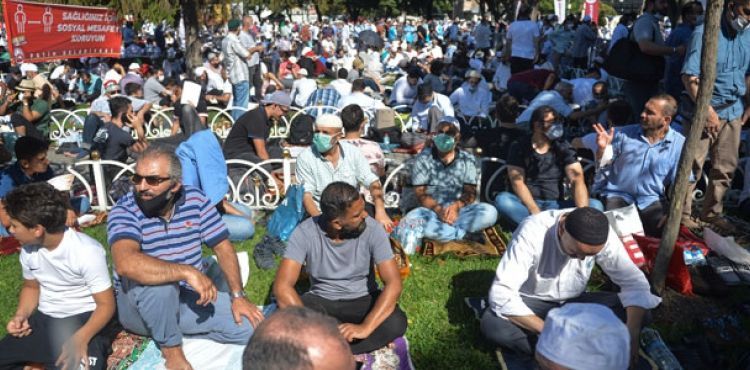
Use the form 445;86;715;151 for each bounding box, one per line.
0;183;115;369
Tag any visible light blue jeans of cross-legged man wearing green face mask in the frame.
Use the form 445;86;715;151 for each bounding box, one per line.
404;203;497;241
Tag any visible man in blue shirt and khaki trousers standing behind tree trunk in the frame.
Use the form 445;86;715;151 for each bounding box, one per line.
682;0;750;233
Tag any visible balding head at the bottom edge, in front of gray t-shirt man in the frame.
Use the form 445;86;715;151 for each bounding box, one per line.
242;307;354;370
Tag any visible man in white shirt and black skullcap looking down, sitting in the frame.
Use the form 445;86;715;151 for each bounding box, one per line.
480;207;661;363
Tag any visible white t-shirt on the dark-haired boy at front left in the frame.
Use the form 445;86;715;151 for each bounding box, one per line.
20;229;112;318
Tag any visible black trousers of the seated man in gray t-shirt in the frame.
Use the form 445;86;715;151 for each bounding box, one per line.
302;292;406;355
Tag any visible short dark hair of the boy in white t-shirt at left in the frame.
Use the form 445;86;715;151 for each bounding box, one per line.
4;182;69;233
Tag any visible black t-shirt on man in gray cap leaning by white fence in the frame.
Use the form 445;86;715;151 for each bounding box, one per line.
224;105;271;159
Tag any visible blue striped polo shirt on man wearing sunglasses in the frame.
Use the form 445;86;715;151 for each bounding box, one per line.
107;185;229;284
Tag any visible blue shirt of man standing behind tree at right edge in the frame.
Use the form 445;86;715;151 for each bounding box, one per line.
682;20;750;121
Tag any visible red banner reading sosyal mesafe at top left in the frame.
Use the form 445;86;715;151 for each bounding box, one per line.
3;0;122;63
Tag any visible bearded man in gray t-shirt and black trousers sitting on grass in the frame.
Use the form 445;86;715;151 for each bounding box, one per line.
273;182;406;355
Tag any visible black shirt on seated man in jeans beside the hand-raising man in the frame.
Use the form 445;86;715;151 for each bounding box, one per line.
508;135;578;200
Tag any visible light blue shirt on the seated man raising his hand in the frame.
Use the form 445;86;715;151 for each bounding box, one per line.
602;124;685;209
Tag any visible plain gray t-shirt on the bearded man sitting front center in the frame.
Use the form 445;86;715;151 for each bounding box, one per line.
284;217;393;300
